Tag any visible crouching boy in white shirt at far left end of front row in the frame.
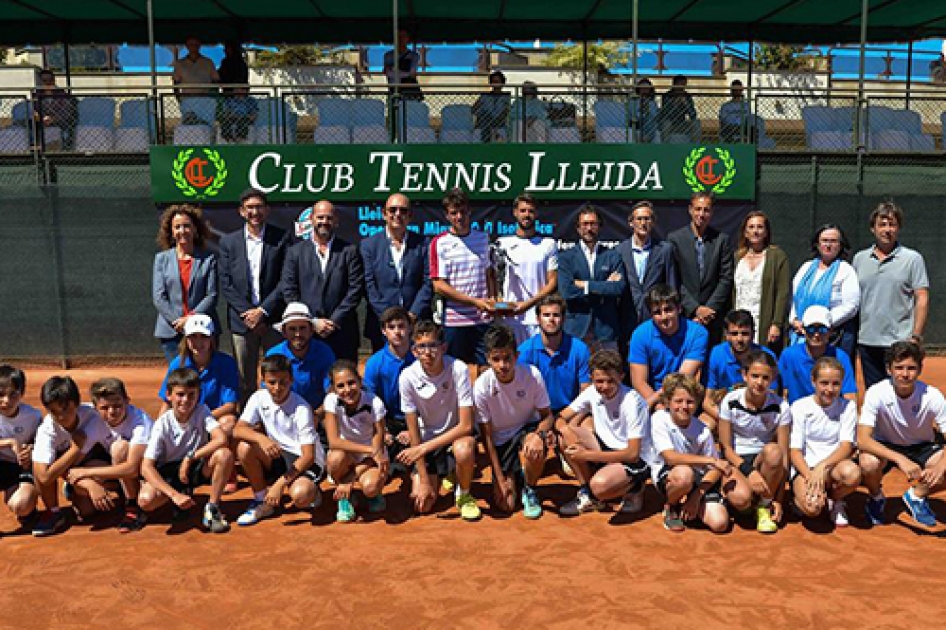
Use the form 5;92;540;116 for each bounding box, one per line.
0;365;43;526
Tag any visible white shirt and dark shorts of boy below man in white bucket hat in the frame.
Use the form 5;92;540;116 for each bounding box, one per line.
240;389;325;483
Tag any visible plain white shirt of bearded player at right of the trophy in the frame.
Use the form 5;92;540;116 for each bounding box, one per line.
497;235;558;325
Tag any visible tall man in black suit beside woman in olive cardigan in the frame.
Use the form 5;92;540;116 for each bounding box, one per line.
667;191;735;348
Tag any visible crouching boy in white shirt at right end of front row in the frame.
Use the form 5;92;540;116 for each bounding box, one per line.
857;341;946;527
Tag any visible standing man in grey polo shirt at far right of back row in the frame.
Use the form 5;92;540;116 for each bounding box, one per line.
853;201;930;387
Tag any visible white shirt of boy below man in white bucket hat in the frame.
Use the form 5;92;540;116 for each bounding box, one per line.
240;389;325;466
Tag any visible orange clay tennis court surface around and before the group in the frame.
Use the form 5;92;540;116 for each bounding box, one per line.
0;359;946;630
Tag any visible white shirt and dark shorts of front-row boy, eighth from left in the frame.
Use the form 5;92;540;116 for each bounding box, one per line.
473;363;551;474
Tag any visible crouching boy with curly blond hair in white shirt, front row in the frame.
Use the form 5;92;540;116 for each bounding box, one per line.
650;372;733;534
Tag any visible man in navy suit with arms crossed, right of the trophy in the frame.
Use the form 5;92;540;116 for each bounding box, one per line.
558;205;624;352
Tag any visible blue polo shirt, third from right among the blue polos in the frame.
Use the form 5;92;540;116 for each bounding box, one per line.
627;317;709;391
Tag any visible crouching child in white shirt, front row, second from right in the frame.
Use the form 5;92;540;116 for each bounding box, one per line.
790;357;861;527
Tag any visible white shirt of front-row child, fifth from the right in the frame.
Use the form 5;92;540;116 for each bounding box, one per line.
568;383;650;460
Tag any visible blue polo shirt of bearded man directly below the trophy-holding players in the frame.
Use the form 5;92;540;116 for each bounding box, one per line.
519;333;591;413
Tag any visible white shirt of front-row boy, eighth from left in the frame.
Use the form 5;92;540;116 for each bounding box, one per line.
473;363;552;444
